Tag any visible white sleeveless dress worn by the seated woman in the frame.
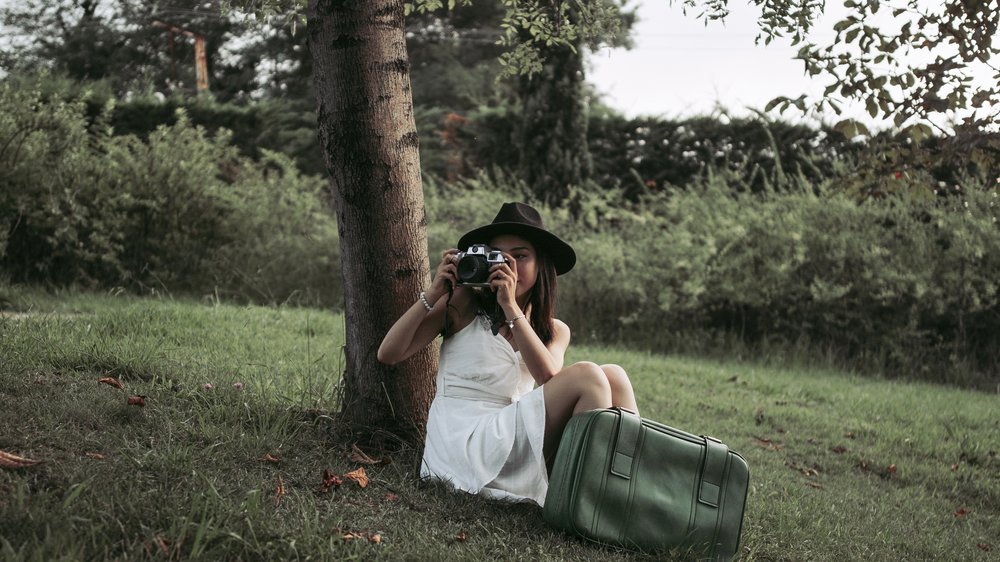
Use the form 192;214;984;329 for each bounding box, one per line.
420;316;549;505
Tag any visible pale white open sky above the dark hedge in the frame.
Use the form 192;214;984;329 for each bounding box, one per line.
587;0;996;127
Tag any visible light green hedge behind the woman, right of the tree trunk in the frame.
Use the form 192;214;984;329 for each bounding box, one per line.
428;173;1000;390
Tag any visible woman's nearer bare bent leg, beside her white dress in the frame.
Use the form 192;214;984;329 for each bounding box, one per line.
542;362;612;470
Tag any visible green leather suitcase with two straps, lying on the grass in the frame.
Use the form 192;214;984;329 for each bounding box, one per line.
543;408;750;560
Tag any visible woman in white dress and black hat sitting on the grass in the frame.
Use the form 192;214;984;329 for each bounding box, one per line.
378;203;637;505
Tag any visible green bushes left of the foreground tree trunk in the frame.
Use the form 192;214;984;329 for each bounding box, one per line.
0;77;340;304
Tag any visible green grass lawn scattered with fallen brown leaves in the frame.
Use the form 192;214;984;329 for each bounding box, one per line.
0;293;1000;561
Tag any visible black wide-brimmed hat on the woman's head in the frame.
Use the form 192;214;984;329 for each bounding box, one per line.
458;203;576;275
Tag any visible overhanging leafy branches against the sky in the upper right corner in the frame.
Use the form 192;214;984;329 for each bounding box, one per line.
683;0;1000;169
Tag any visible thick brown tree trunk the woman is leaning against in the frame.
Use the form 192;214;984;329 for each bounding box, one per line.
308;0;437;441
